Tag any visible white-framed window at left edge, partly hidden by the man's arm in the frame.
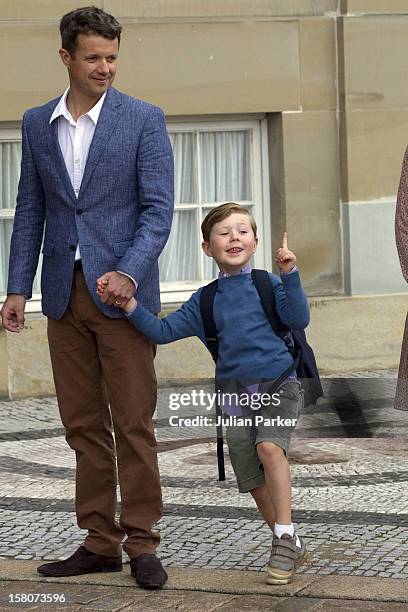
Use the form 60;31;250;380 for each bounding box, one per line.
0;128;41;311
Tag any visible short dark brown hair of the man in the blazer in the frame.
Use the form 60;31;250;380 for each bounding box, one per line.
60;6;122;56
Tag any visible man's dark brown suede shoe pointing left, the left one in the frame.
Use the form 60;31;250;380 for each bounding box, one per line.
37;546;122;576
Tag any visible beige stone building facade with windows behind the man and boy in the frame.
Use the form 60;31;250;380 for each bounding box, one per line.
0;0;408;397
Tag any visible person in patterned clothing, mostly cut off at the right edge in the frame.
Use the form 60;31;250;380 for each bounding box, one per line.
394;149;408;410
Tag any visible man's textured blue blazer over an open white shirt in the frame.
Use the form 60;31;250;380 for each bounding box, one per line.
7;87;174;319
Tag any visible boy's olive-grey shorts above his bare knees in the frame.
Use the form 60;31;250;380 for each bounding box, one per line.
226;382;304;493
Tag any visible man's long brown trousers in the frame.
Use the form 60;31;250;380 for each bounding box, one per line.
48;272;162;558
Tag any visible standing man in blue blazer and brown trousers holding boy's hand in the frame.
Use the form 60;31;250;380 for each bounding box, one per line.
1;7;173;588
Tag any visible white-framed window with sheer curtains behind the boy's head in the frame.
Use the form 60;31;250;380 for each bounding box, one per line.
159;120;269;302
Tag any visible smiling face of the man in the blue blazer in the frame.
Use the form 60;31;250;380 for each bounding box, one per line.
59;34;119;98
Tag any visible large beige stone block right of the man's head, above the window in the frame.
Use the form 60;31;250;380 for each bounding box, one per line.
113;20;300;115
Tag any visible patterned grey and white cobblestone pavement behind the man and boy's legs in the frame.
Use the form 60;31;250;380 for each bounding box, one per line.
0;371;408;579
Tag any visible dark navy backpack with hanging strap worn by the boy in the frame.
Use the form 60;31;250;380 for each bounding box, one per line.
200;269;323;480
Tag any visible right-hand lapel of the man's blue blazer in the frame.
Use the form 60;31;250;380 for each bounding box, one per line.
79;88;122;197
